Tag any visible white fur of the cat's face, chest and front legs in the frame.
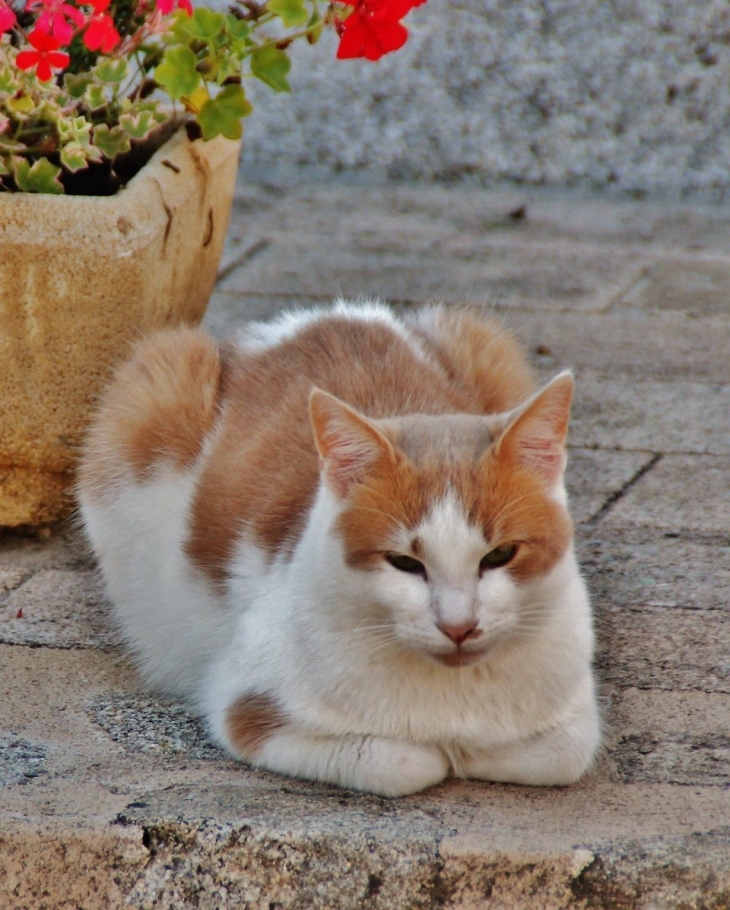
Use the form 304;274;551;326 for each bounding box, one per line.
198;486;599;796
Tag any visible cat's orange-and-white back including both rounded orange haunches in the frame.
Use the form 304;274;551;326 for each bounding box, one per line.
80;303;534;585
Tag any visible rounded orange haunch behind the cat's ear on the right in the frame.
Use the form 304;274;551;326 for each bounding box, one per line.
409;306;537;414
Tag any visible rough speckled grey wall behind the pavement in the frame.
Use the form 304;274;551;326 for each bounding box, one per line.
235;0;730;196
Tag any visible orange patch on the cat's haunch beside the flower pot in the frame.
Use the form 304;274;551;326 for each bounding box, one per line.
79;329;220;496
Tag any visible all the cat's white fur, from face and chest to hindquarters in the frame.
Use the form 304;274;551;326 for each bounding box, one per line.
82;307;600;796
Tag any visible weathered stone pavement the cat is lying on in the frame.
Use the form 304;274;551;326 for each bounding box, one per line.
0;173;730;910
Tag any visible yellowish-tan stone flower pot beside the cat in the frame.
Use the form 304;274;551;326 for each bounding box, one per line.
0;131;239;527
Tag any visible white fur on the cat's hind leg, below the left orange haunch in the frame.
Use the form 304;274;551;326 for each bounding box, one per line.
82;463;232;702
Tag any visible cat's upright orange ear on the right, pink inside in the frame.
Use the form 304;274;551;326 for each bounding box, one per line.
496;372;573;487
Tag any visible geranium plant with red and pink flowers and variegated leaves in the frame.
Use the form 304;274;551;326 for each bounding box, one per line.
0;0;425;194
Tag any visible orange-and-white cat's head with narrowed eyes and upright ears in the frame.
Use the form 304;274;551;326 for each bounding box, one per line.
310;373;573;666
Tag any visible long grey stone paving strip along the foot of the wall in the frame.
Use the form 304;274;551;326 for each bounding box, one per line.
231;182;730;261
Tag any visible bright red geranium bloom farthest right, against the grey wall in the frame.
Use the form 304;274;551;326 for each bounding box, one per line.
337;0;426;60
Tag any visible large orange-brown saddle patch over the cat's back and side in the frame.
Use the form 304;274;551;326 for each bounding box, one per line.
186;315;474;585
